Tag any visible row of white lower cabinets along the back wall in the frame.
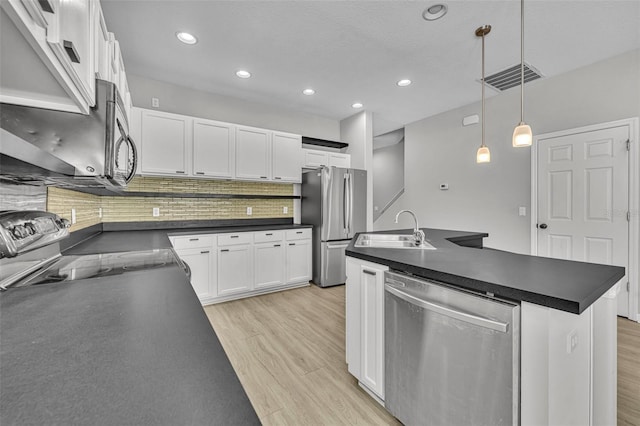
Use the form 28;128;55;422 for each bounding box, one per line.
169;228;311;305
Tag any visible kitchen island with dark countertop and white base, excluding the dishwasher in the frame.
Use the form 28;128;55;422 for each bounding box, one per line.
346;229;624;425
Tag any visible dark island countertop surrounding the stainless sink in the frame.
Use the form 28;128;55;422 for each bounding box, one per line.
346;228;625;314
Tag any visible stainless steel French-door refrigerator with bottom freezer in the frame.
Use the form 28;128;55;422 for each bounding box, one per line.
301;167;367;287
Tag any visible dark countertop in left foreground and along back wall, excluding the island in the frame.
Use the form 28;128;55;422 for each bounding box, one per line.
0;224;316;425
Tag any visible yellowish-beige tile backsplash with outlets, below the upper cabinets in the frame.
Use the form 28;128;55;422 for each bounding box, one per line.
47;177;293;231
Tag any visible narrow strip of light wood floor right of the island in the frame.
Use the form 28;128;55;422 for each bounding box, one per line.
618;318;640;426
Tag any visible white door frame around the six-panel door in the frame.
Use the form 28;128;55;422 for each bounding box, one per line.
531;117;640;322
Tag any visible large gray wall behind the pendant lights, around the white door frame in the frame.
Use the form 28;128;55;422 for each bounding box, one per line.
375;50;640;253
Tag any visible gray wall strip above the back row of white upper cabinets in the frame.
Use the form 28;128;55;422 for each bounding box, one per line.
127;75;340;140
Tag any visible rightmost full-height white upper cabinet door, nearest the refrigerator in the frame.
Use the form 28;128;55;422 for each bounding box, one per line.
271;132;303;183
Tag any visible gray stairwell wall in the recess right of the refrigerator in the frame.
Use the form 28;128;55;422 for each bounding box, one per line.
373;139;404;222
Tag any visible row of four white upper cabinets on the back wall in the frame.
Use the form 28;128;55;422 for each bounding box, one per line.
130;108;303;183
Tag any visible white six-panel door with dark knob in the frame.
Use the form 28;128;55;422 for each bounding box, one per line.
537;126;630;316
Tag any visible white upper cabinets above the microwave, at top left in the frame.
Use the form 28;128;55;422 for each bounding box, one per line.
0;0;131;114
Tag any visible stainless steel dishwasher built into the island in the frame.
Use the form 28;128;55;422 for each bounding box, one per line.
385;272;520;426
